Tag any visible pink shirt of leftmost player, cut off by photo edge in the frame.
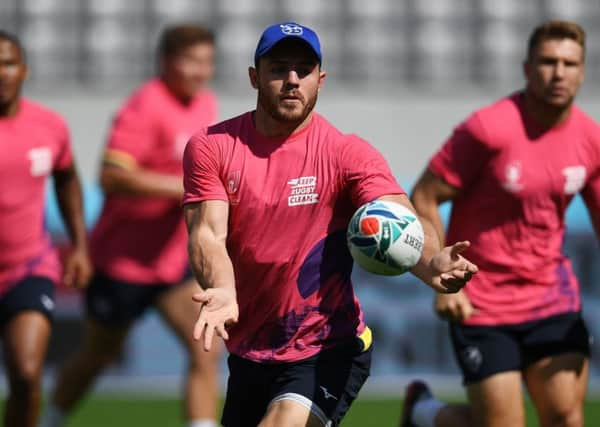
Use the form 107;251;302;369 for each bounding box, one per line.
0;98;73;295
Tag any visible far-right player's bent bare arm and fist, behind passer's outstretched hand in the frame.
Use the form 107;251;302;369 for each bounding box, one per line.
411;169;476;321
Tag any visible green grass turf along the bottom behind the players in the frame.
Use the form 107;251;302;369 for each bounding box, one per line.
7;396;600;427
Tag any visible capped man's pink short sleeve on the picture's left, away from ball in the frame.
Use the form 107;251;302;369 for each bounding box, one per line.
183;129;229;205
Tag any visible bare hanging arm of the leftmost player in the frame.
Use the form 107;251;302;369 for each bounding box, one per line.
53;164;92;288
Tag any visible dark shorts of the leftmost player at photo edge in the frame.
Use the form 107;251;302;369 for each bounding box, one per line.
0;276;54;328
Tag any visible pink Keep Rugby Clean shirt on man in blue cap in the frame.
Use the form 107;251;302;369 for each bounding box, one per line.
184;112;404;362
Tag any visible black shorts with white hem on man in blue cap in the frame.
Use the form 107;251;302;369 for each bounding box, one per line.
221;343;372;427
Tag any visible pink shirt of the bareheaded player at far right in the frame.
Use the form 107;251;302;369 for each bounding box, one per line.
429;93;600;325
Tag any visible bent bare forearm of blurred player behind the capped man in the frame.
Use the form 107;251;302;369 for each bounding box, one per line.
100;163;183;200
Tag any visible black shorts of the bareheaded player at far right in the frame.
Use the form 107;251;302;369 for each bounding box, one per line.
450;313;590;384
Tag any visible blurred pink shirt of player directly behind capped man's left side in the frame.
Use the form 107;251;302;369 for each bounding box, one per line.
91;79;217;285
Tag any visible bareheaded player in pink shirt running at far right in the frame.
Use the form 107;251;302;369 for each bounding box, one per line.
402;21;600;427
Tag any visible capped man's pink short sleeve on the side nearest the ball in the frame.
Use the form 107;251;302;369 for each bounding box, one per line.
339;136;405;206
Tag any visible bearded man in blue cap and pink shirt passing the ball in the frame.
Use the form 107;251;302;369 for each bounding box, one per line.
183;22;476;427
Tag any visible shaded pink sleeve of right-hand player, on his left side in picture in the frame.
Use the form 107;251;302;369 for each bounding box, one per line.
429;114;493;188
